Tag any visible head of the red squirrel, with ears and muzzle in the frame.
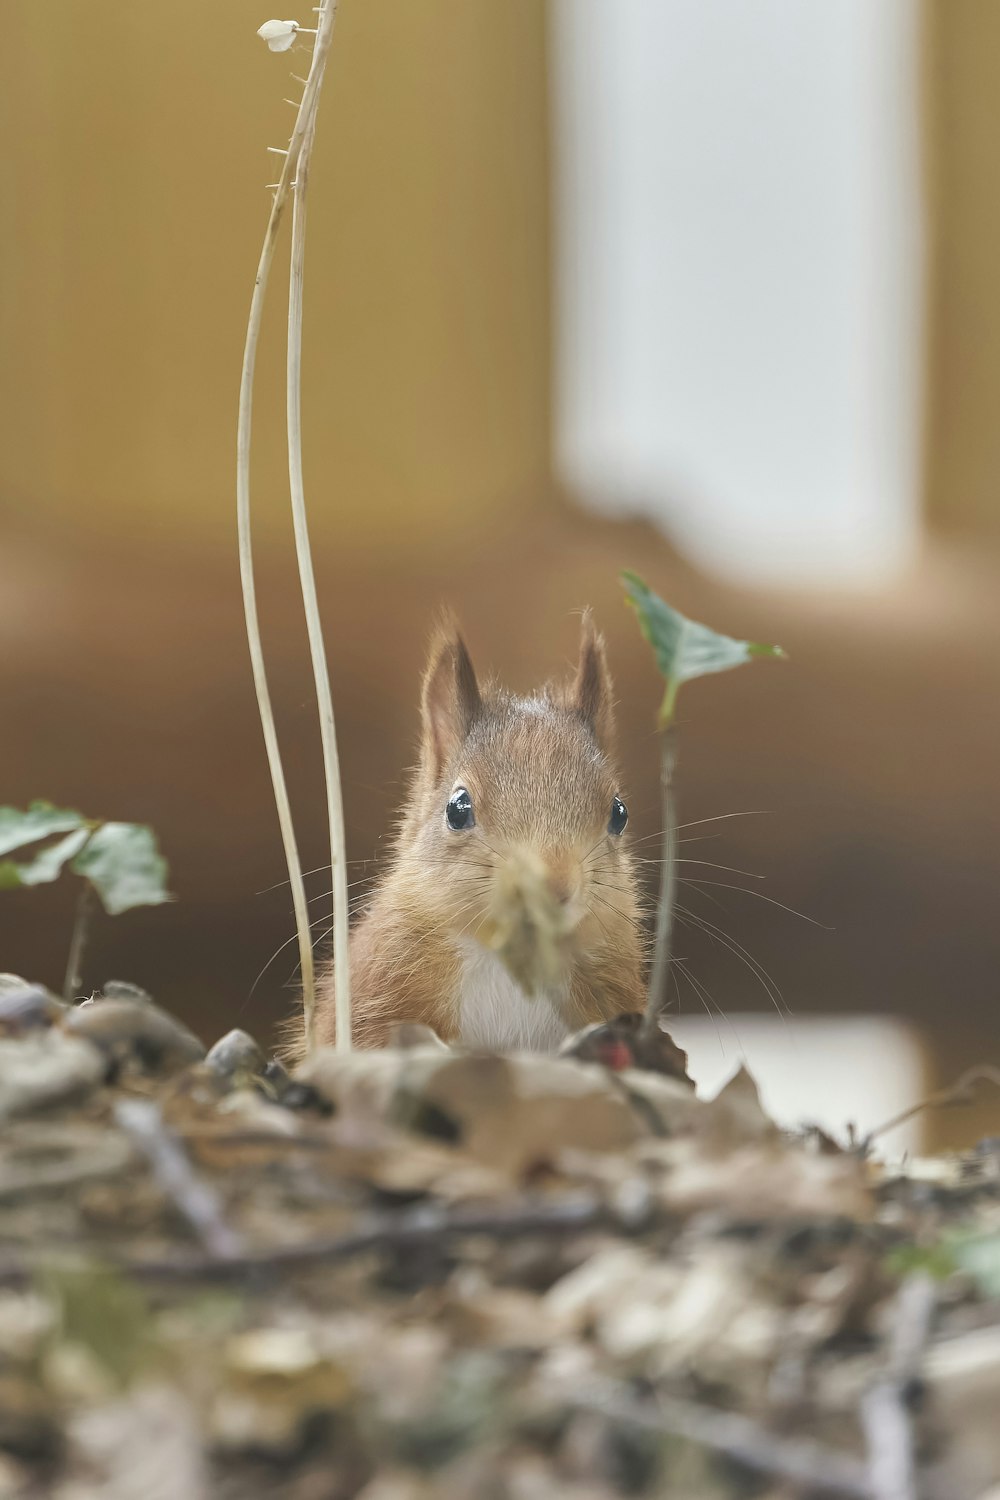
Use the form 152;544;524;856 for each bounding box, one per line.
400;611;636;989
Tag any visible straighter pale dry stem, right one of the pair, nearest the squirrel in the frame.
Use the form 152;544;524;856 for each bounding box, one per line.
286;108;351;1052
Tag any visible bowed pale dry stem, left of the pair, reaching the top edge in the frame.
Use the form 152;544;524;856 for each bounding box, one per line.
237;0;336;1044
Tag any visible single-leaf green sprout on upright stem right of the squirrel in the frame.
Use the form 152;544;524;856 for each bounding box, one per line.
621;570;786;1032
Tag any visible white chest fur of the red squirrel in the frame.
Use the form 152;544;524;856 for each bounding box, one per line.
459;938;570;1052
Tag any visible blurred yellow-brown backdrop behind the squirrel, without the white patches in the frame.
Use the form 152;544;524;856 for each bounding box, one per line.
0;0;1000;1133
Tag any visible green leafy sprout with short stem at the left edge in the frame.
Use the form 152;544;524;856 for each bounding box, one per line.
0;803;172;1001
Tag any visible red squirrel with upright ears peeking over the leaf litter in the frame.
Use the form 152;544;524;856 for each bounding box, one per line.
308;611;645;1052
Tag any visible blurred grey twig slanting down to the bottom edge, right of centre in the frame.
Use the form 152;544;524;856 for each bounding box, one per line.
574;1391;874;1500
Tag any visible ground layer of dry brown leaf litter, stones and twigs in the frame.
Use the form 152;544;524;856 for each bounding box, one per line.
0;977;1000;1500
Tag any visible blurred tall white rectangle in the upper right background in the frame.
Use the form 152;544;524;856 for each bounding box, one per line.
550;0;922;585
